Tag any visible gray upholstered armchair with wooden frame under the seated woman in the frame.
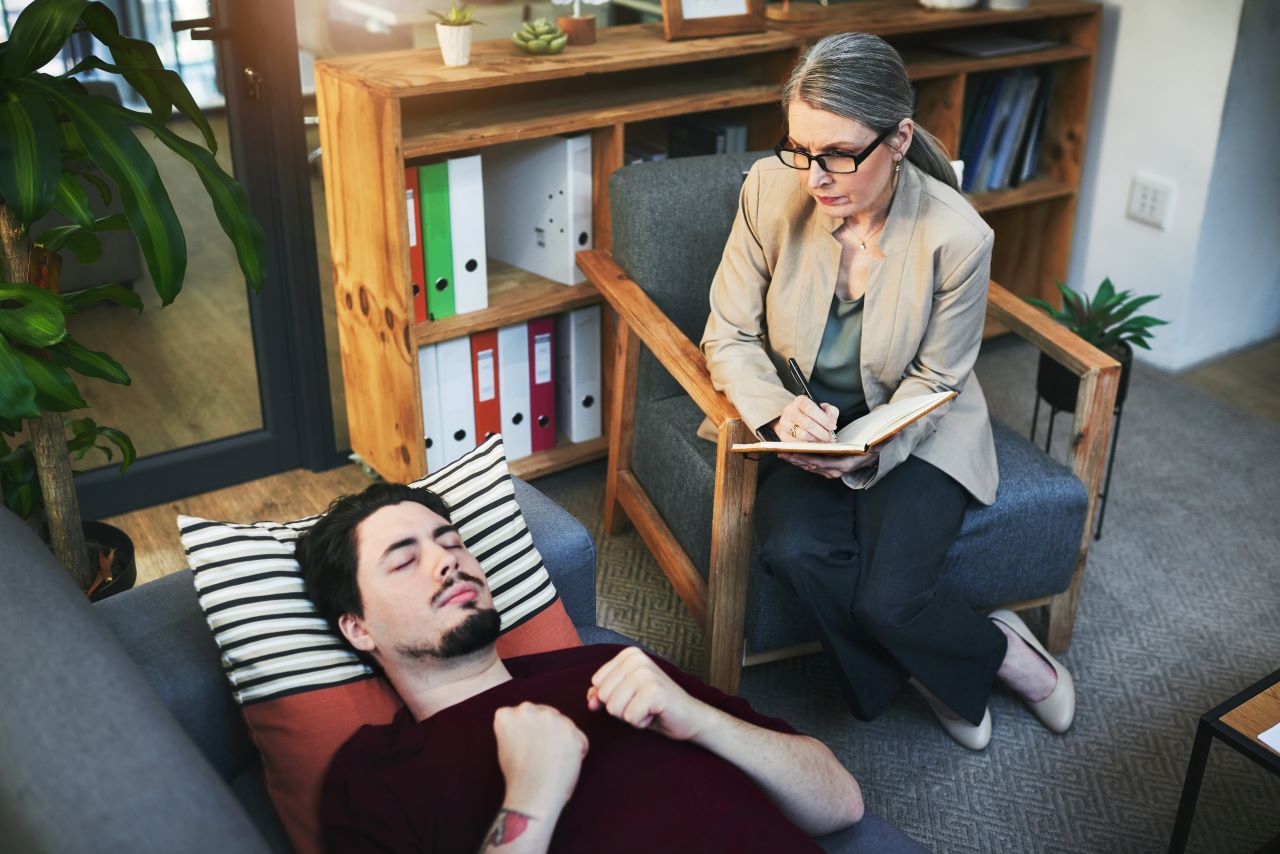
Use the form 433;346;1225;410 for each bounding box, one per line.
579;152;1119;691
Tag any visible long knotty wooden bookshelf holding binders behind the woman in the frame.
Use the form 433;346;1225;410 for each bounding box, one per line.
316;0;1101;480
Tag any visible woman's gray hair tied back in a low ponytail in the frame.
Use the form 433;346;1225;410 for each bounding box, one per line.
782;32;960;189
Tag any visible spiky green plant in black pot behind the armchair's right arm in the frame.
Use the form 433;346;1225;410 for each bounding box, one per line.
1028;278;1167;412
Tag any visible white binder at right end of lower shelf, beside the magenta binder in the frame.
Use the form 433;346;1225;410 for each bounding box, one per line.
556;305;603;442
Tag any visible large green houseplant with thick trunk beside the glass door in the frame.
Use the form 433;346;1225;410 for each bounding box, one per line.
0;0;265;588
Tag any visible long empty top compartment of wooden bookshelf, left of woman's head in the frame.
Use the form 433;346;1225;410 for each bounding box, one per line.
402;74;782;160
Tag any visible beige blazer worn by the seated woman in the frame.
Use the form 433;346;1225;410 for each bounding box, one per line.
699;157;998;504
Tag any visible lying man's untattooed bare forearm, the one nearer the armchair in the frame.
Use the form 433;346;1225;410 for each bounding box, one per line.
694;705;863;836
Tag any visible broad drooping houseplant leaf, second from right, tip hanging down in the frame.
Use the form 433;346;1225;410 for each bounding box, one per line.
26;74;188;305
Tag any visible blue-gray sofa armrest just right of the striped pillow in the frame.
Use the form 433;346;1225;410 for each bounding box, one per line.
512;478;595;626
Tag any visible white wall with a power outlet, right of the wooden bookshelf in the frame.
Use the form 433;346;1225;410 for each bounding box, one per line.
1069;0;1280;370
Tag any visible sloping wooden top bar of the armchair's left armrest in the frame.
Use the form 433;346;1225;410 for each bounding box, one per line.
577;250;740;428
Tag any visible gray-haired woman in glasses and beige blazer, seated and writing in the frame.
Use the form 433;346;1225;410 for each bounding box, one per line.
701;33;1075;749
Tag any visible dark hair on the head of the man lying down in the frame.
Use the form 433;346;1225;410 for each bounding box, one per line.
297;483;449;634
